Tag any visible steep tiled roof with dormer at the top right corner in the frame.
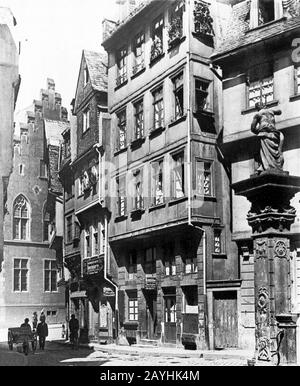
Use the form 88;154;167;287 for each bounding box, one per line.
212;0;300;60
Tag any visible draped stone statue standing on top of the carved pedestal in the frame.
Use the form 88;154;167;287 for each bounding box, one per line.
251;103;284;173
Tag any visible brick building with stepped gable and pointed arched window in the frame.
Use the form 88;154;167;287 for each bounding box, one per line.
0;79;69;328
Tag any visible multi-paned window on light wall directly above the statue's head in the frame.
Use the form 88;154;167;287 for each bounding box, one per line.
249;76;274;107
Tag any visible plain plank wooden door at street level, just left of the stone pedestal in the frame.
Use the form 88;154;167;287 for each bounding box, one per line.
213;291;238;349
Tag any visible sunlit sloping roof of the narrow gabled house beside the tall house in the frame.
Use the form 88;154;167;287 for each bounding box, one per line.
83;50;108;92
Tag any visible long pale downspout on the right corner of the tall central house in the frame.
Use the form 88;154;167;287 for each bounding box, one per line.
187;0;207;348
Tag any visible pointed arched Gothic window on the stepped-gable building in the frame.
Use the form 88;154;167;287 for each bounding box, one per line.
13;195;30;240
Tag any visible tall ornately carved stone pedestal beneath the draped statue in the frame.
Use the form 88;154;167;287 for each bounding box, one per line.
232;170;300;363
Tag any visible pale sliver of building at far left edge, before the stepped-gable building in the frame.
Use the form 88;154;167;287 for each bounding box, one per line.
0;7;20;272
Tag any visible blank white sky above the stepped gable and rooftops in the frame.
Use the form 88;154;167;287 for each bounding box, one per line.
0;0;115;120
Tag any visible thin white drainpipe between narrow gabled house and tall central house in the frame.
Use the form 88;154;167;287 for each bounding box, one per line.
94;143;119;337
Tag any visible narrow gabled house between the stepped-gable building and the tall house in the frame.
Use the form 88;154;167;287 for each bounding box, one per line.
60;50;114;341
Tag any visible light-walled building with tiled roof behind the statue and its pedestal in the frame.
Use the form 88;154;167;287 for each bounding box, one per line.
212;0;300;347
